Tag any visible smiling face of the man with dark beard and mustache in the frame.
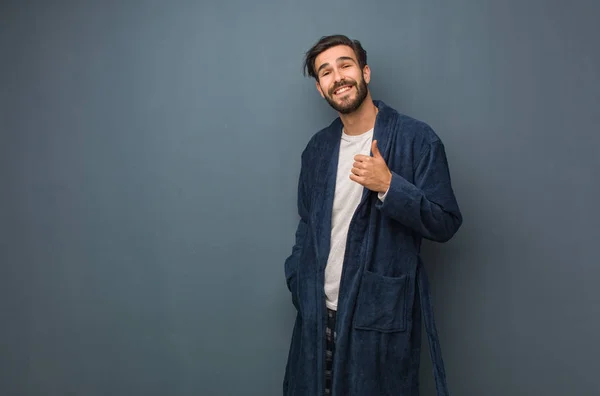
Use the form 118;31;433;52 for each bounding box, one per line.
315;45;370;114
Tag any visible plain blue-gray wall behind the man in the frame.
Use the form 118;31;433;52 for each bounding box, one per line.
0;0;600;396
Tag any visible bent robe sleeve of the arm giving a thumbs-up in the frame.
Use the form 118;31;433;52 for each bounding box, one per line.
376;140;462;242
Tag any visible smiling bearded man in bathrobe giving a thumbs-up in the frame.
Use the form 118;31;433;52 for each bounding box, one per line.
284;35;462;396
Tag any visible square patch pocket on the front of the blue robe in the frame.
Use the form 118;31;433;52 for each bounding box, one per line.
354;271;410;333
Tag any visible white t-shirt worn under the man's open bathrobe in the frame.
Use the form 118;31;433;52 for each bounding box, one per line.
325;129;381;310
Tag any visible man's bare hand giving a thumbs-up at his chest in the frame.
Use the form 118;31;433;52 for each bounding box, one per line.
350;140;392;193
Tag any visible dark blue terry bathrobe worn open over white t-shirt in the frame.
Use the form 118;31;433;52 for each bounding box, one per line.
283;101;462;396
